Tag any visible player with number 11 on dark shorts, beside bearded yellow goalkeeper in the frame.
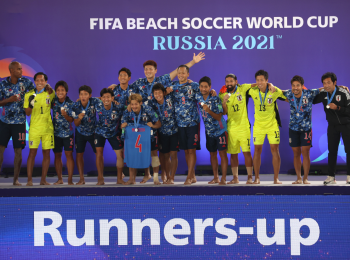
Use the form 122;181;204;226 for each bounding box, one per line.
196;77;228;185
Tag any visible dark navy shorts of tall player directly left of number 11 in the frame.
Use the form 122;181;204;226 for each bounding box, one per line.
179;124;201;150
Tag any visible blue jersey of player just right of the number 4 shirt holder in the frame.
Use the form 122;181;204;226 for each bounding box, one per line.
145;93;178;135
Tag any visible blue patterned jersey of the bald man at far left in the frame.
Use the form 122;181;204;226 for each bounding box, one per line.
0;77;35;124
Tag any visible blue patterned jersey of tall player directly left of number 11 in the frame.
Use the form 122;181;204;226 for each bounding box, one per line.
172;81;200;127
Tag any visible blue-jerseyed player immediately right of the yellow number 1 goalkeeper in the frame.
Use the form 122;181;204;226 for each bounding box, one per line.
52;80;74;185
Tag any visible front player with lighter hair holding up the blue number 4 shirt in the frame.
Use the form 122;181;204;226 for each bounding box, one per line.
121;94;162;185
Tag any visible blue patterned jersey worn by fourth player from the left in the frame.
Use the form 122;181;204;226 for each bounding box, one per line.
73;98;101;136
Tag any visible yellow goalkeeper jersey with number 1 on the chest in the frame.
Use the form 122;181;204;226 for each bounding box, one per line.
23;89;55;134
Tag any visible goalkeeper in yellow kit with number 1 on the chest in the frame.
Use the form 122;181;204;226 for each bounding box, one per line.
23;72;55;186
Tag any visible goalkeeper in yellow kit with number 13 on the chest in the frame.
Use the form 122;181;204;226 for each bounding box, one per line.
248;70;286;184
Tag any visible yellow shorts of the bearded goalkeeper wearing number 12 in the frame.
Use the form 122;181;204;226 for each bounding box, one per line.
227;128;250;154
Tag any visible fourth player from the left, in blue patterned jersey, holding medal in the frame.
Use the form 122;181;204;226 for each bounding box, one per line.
73;85;104;185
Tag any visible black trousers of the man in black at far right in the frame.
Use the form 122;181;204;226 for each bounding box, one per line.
327;124;350;176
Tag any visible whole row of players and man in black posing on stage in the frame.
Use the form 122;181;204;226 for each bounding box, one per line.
0;53;350;186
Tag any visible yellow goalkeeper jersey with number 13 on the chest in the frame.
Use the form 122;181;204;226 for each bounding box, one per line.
248;87;287;130
